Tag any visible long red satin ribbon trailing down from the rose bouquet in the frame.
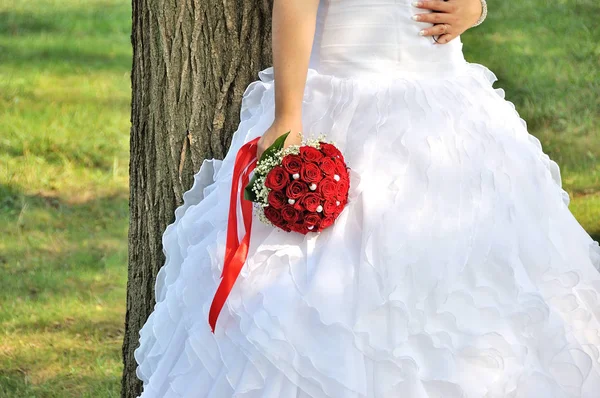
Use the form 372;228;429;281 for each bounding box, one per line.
208;137;260;333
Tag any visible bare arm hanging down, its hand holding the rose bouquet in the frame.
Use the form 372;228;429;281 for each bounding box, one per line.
258;0;319;157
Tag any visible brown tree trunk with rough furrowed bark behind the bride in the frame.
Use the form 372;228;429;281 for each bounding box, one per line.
121;0;272;397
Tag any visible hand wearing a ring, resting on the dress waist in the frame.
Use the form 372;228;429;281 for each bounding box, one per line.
415;0;482;44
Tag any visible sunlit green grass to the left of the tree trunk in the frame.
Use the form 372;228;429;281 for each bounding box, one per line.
0;0;131;398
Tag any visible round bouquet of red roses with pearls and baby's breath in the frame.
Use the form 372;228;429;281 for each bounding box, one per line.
244;131;350;234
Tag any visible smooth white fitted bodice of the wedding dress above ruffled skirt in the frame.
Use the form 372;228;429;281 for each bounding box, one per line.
310;0;465;78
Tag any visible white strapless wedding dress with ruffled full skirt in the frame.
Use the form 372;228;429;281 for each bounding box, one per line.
135;0;600;398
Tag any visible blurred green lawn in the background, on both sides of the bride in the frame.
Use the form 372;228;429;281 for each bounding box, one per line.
0;0;600;398
